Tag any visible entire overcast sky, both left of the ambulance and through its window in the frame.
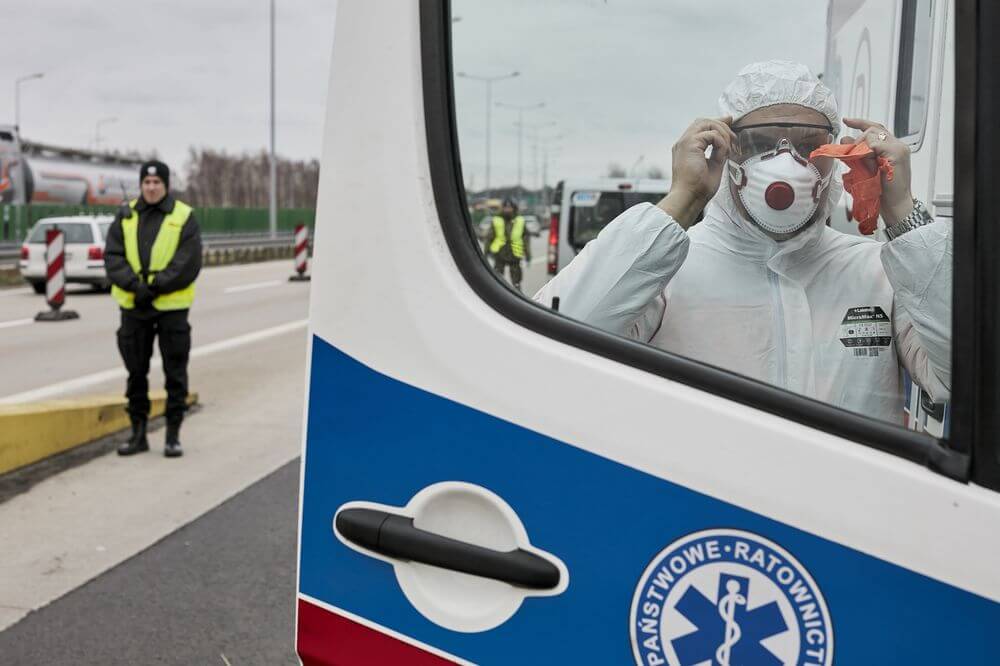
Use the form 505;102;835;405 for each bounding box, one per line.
7;0;827;189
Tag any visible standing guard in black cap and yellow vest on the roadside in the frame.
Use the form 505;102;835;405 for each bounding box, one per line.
104;160;201;458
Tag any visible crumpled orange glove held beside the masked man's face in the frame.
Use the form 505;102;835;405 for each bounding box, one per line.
809;141;893;236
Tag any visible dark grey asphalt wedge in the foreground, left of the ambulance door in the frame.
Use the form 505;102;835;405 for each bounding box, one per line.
0;460;299;666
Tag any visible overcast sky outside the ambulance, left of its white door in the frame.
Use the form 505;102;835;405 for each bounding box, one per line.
0;0;336;182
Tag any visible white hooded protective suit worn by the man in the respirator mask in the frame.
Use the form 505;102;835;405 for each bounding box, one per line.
535;61;952;423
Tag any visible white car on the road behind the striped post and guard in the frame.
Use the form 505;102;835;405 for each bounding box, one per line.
19;215;114;294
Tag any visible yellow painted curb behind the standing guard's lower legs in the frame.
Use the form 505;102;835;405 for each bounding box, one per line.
0;391;198;474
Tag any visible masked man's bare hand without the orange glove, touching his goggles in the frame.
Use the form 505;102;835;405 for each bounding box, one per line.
657;116;736;229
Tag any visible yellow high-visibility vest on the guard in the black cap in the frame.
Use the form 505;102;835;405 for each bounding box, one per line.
111;199;194;311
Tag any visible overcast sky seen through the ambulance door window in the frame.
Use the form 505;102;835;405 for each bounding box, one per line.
452;0;827;189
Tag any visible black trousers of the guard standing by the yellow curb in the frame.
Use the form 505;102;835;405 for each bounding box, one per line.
118;310;191;424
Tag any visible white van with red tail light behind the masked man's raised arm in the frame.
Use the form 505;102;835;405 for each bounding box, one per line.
547;178;670;275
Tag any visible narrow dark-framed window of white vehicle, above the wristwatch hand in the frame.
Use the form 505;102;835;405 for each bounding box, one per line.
895;0;934;137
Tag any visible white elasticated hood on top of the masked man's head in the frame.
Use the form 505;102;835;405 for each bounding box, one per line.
719;60;840;134
